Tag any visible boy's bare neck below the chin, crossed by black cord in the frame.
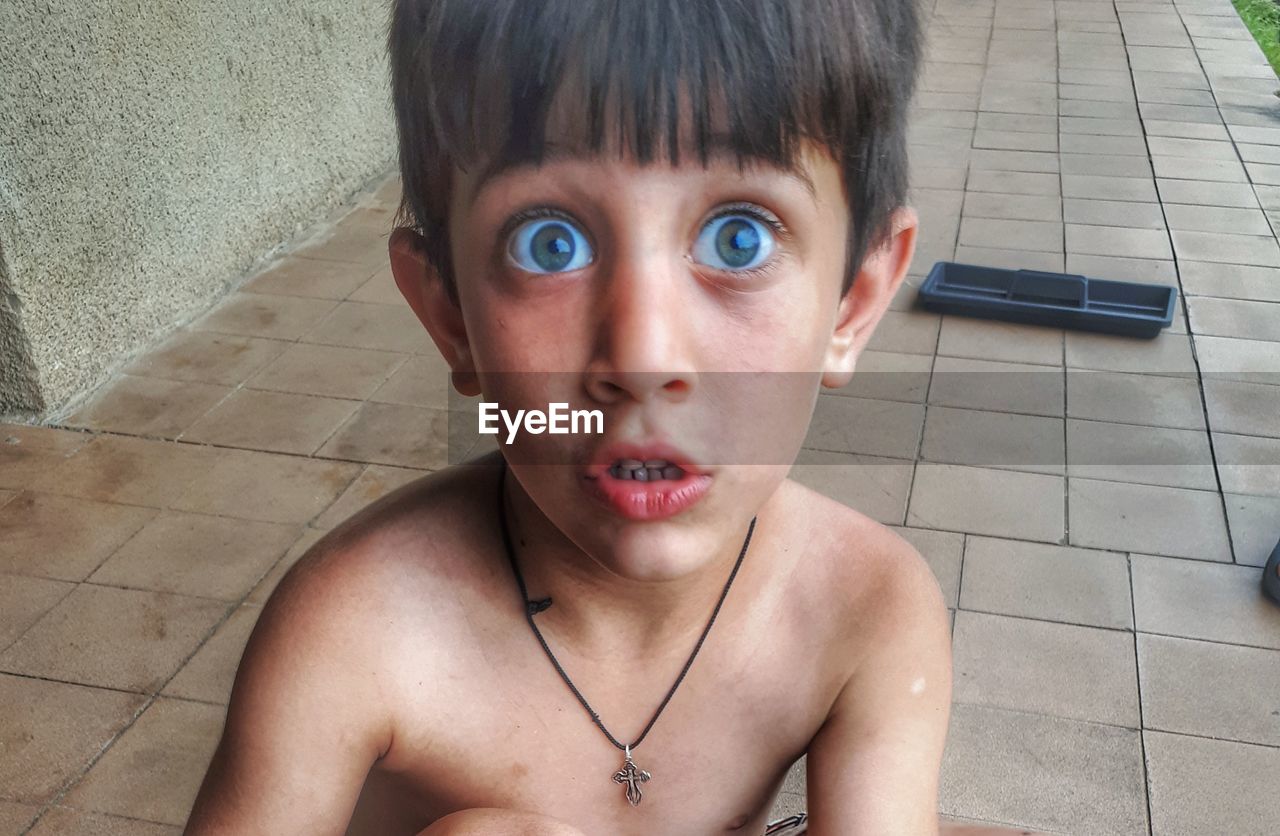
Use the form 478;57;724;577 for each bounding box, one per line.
503;466;754;662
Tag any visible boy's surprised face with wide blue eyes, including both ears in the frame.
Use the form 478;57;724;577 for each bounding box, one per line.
392;138;915;579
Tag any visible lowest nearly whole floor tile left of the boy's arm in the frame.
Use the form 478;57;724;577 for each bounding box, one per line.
65;698;224;826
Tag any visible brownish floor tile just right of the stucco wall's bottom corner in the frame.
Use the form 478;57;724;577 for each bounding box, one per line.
64;375;232;438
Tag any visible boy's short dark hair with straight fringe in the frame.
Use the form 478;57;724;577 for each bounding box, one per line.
388;0;923;300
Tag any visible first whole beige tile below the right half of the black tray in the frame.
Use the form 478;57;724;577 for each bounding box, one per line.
1066;369;1204;430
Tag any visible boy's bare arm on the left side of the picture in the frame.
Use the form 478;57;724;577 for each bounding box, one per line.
186;538;390;836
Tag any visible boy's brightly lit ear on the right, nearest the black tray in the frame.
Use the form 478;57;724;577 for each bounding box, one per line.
822;206;919;389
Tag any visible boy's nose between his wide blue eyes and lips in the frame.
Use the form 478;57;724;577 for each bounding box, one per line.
586;245;696;403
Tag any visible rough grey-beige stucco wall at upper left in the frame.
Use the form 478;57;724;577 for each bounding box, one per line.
0;0;394;415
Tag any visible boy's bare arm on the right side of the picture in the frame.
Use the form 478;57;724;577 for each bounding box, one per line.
808;544;951;836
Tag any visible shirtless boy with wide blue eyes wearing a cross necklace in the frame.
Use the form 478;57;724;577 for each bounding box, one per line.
188;0;972;836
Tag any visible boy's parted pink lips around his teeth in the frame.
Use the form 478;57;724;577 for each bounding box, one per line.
582;443;712;521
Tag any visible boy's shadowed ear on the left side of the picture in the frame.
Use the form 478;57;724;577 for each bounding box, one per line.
388;227;480;397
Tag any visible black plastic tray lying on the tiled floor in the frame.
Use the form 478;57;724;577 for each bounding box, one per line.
920;261;1178;338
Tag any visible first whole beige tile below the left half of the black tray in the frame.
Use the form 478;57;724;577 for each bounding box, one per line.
929;357;1066;417
